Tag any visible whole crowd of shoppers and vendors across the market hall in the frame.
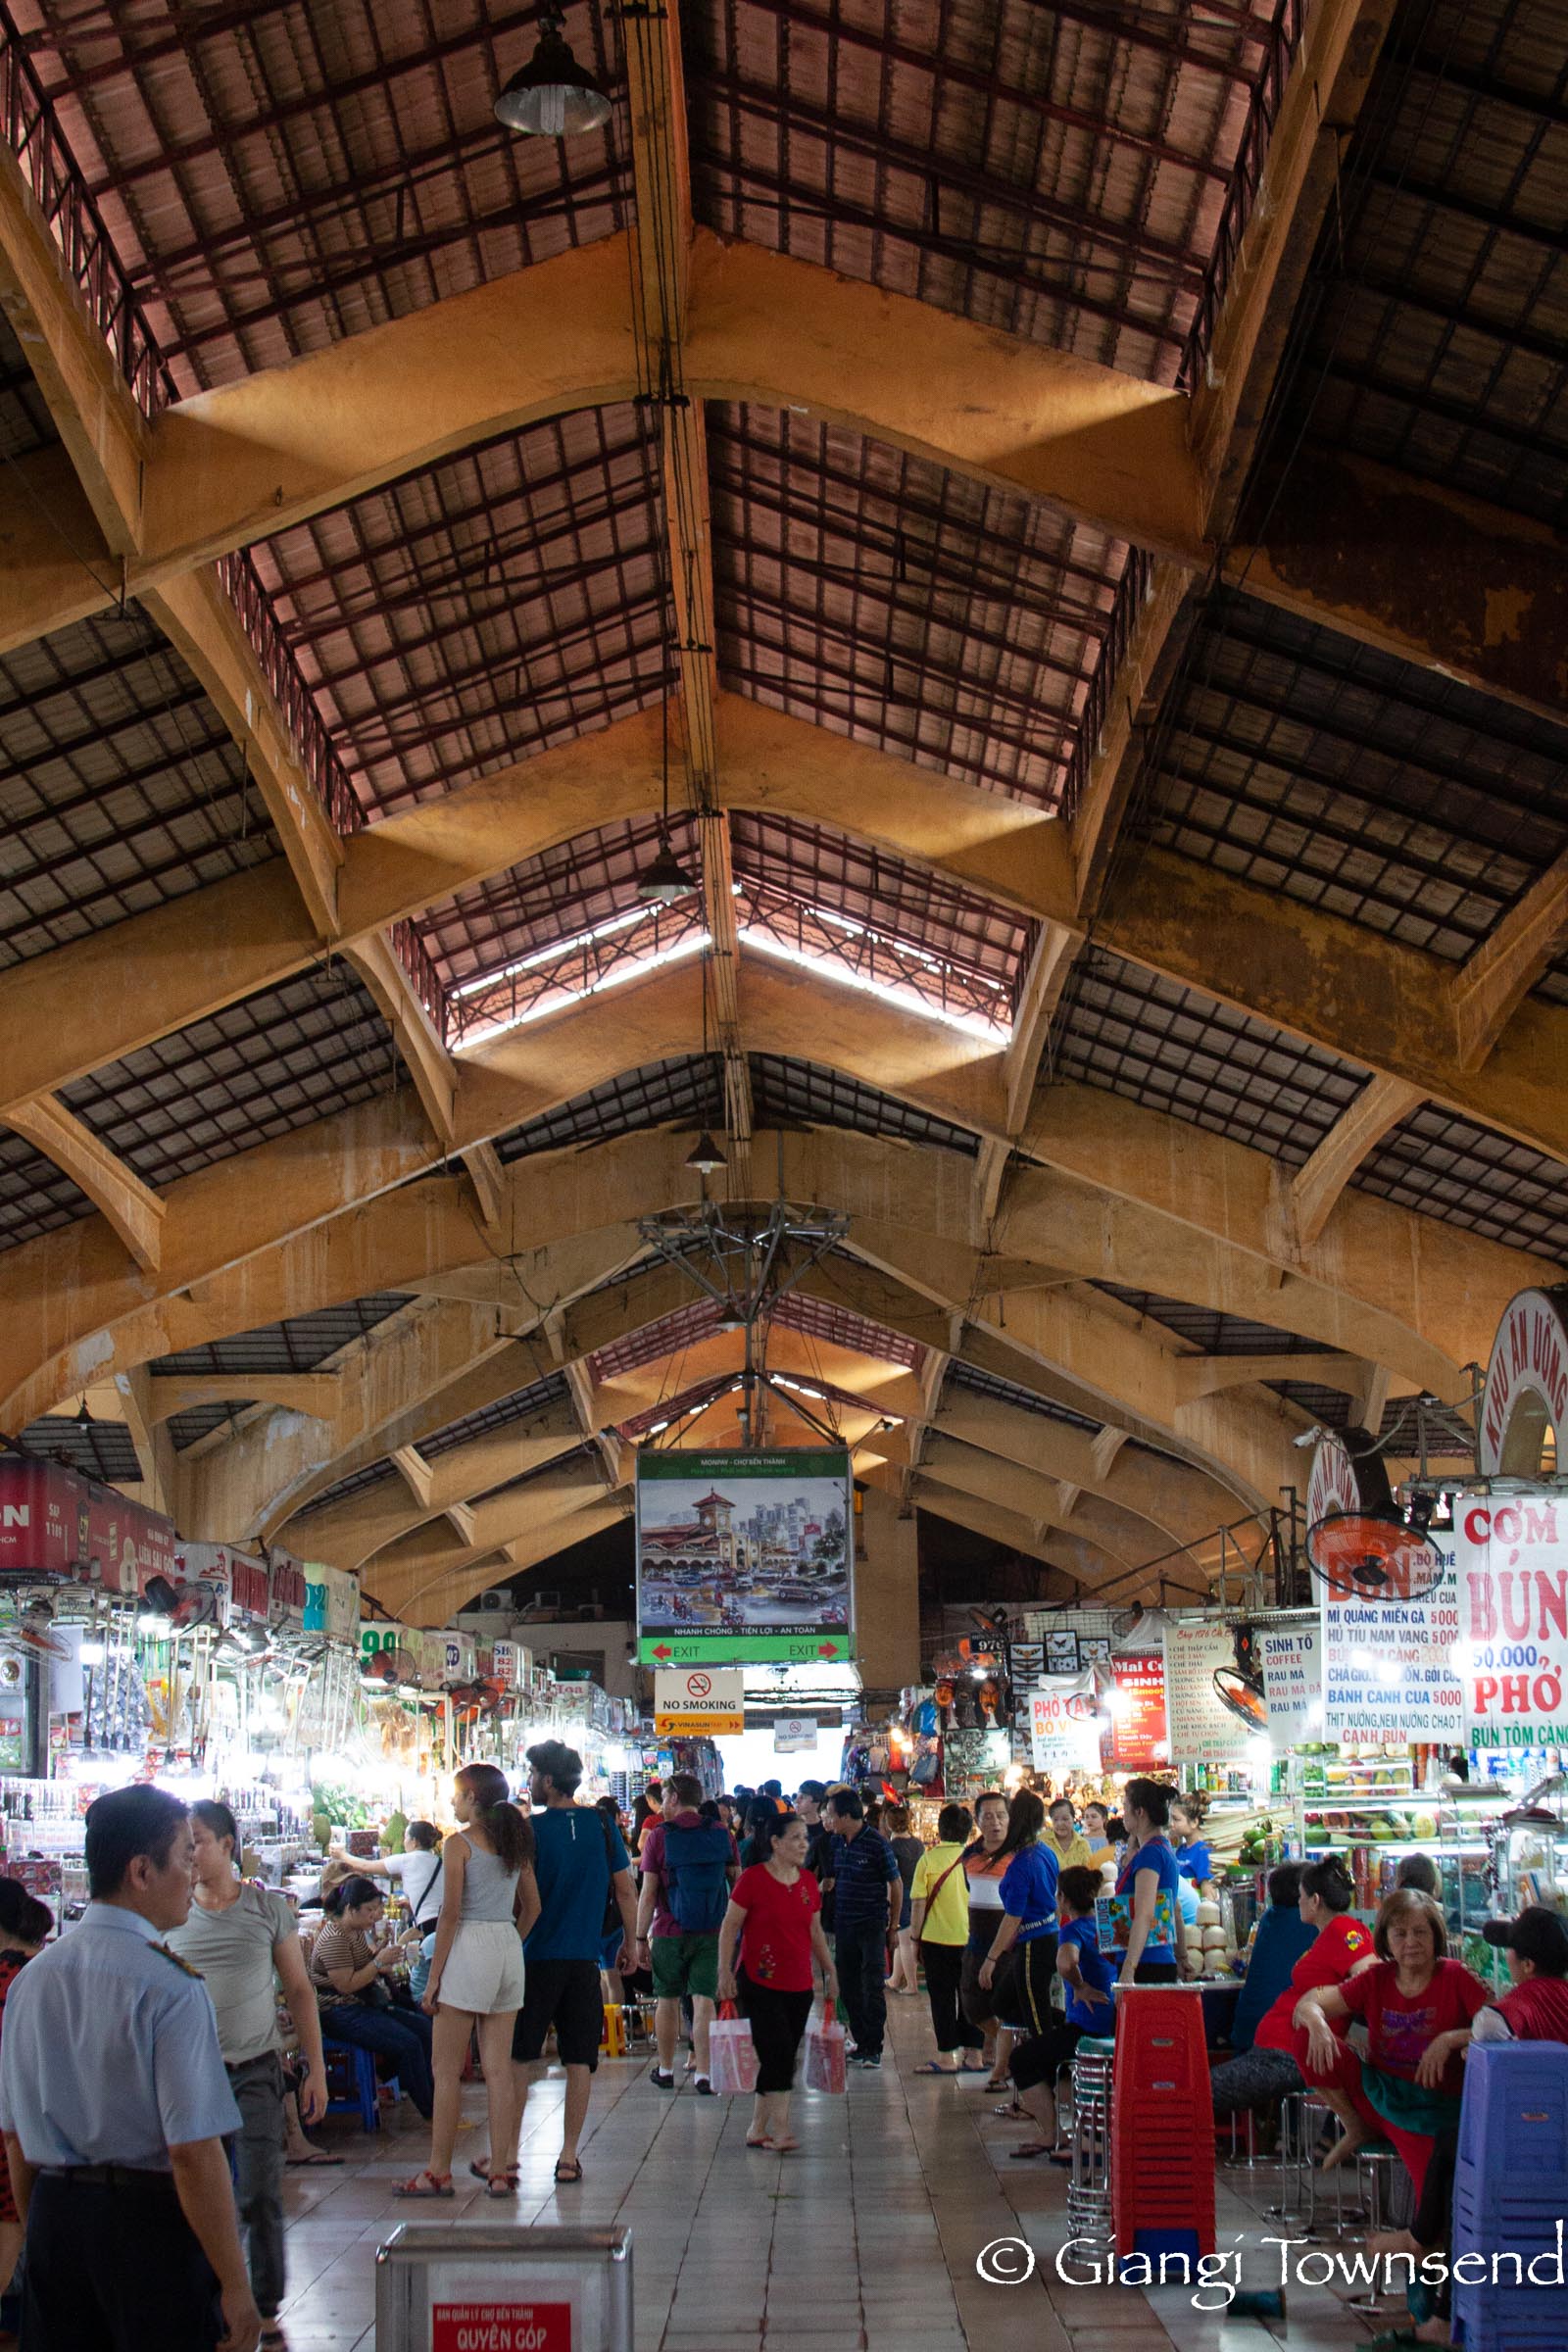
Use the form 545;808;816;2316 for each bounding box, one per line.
0;1768;1568;2352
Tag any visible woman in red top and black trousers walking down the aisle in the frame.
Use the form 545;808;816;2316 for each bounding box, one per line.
719;1813;839;2154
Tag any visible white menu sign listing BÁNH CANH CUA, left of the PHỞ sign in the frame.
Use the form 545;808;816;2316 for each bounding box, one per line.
1321;1552;1464;1747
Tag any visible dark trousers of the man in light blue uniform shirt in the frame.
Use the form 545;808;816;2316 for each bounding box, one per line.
22;2174;223;2352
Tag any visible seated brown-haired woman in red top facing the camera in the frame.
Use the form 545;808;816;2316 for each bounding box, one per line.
1296;1886;1488;2201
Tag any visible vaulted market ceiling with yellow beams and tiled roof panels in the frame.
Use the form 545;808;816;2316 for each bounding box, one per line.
0;0;1568;1618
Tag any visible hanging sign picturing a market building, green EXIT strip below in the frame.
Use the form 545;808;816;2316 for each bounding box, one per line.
637;1448;856;1668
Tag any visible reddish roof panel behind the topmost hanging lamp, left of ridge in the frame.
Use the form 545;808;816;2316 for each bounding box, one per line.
17;0;630;393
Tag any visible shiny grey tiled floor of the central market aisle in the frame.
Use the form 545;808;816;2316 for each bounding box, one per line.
272;2001;1387;2352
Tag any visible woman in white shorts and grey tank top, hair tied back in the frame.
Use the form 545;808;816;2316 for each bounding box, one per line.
397;1764;538;2197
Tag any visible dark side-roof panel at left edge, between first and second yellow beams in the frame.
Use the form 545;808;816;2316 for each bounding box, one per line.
0;605;279;964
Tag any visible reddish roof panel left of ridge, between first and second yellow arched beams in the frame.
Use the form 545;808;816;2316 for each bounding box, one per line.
256;407;670;816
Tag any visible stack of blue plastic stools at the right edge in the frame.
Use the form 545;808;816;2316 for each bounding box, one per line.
1452;2041;1568;2352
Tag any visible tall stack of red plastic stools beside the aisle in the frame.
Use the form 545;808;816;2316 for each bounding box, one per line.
1109;1985;1213;2260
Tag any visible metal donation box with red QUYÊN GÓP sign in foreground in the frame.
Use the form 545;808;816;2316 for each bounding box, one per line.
376;2223;632;2352
